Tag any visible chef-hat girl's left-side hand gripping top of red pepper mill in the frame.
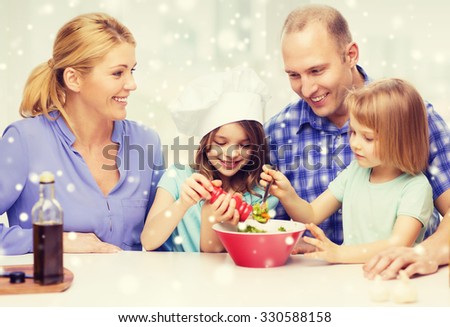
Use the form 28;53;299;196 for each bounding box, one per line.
179;173;213;207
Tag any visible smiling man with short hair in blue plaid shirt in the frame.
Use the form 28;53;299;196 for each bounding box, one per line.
265;5;450;252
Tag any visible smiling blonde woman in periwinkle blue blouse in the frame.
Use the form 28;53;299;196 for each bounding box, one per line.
0;13;162;254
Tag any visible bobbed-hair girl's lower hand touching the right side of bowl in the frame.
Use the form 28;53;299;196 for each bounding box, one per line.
303;224;340;262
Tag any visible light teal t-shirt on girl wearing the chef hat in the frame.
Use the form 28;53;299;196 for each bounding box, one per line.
158;165;278;252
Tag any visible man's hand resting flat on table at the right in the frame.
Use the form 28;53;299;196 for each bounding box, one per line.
363;245;439;279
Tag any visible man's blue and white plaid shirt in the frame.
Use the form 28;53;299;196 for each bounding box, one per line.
265;66;450;244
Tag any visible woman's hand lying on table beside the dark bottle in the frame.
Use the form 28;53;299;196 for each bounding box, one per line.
63;232;122;253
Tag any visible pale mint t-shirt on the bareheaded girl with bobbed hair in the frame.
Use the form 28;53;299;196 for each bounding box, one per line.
328;160;433;245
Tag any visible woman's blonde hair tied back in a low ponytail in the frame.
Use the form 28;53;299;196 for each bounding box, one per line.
19;13;136;118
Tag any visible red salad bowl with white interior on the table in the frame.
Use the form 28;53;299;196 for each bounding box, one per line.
213;219;305;268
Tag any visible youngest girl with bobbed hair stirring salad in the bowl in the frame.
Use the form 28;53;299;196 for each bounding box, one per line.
261;79;433;263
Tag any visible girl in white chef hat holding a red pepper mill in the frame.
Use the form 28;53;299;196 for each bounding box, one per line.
141;67;278;252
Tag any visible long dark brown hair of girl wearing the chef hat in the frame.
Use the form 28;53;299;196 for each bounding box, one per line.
192;120;269;195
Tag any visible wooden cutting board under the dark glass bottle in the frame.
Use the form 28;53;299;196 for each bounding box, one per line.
0;265;73;295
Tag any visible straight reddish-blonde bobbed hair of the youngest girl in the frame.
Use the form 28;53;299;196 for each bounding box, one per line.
344;78;429;175
